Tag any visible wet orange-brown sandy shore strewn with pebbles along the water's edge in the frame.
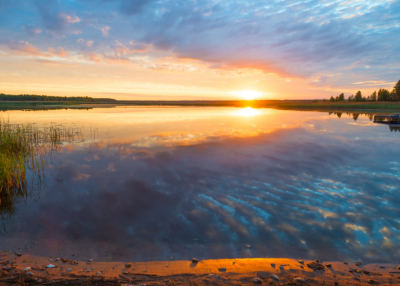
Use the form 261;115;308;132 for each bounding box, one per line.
0;252;400;285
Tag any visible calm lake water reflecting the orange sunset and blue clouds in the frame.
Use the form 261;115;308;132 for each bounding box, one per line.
0;107;400;262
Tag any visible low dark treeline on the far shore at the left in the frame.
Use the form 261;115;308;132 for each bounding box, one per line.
0;93;117;102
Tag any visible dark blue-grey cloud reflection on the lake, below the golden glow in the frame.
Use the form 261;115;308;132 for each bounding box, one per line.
0;113;400;262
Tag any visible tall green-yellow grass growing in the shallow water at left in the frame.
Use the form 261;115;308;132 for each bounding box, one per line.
0;119;62;225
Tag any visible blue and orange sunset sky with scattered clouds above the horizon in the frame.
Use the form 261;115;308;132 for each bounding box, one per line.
0;0;400;100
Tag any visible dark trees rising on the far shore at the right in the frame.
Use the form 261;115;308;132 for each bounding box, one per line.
323;80;400;102
